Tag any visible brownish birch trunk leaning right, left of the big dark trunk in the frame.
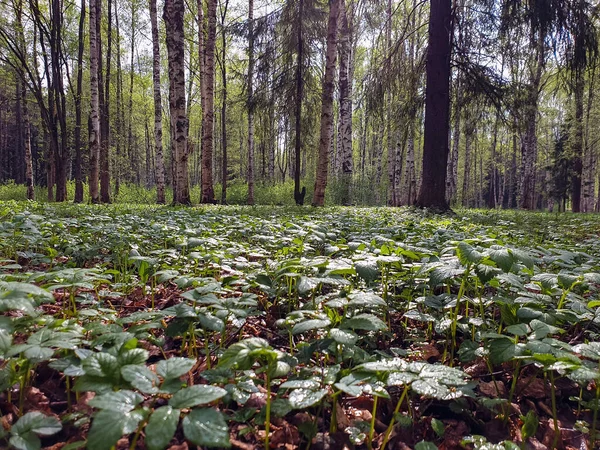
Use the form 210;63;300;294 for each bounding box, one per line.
312;0;340;206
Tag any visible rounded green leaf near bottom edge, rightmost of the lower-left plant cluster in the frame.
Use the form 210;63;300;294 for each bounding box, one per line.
183;408;231;448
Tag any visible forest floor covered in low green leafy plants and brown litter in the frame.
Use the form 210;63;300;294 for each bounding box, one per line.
0;202;600;450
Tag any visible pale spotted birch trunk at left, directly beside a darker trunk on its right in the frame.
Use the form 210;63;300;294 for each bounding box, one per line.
89;0;100;203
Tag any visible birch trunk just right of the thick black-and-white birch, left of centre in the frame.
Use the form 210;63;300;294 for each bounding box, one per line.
200;0;217;203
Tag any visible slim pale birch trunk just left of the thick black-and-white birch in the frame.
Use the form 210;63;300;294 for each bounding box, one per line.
150;0;166;204
